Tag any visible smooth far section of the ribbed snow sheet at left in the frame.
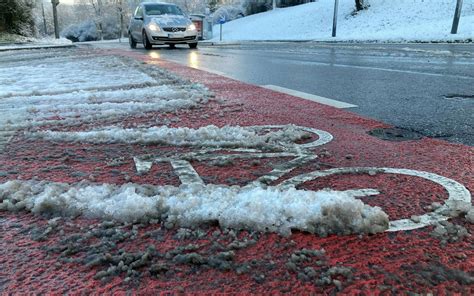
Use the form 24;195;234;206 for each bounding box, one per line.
0;56;155;97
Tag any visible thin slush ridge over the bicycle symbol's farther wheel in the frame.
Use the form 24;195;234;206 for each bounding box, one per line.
27;125;308;148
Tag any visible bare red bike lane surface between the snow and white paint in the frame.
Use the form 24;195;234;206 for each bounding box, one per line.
0;50;474;295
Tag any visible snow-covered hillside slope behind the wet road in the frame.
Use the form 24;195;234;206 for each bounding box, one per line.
213;0;474;41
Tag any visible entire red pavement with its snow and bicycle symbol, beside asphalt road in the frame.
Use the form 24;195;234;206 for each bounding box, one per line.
0;47;474;295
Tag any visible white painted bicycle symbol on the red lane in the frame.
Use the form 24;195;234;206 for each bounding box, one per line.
134;125;471;231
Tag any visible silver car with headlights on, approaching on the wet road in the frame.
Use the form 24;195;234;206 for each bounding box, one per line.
128;2;198;49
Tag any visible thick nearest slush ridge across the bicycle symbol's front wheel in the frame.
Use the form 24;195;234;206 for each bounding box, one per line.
0;180;388;235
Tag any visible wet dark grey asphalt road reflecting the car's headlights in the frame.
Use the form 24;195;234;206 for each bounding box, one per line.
92;42;474;146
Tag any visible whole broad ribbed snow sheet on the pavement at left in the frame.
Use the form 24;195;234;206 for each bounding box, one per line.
0;50;209;130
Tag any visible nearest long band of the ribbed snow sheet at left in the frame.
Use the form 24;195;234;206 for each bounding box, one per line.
0;85;207;129
